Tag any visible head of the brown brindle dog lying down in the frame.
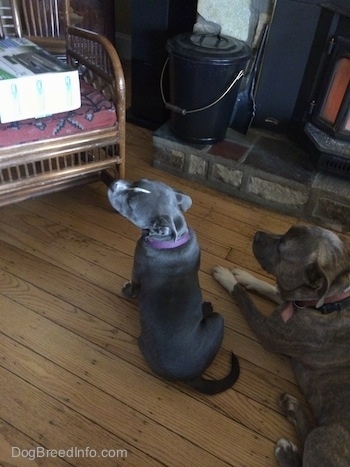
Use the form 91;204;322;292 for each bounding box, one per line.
253;226;350;306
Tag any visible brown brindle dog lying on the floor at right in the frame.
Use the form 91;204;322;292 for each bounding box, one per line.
214;226;350;467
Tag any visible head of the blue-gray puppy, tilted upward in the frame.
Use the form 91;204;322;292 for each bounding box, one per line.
108;179;192;239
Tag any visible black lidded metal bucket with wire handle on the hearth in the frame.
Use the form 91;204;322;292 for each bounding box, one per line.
166;33;251;144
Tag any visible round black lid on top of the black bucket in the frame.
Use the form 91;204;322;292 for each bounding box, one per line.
166;33;251;62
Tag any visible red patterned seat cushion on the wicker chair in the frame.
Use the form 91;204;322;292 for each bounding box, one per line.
0;80;116;147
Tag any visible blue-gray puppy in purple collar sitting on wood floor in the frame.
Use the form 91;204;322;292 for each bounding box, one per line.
108;179;239;394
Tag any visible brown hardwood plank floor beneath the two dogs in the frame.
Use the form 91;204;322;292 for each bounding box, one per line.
0;124;326;467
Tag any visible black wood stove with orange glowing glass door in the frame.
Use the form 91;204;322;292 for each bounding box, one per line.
293;4;350;178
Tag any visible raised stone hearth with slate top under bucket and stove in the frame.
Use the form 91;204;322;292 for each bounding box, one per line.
153;123;350;232
